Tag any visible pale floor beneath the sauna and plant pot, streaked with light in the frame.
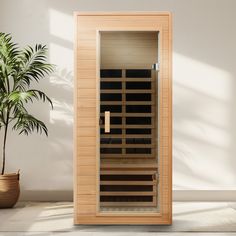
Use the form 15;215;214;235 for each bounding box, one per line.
0;202;236;236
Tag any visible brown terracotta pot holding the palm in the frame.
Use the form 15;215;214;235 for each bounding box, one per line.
0;173;20;208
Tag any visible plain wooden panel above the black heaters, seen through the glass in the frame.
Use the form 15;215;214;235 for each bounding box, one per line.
101;32;158;69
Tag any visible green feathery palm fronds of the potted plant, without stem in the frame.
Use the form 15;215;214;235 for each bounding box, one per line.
0;32;55;135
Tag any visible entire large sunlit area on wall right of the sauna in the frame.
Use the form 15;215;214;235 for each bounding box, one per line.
173;53;236;190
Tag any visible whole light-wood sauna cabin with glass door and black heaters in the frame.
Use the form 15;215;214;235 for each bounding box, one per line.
74;12;172;224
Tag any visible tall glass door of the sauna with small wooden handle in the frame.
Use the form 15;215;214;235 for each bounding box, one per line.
99;31;159;212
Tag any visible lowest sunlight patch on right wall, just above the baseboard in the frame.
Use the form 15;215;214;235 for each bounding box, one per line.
173;144;236;190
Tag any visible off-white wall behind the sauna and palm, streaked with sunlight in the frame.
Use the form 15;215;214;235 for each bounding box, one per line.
0;0;236;200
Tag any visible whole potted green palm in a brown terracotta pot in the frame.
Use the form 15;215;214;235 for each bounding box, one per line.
0;33;53;208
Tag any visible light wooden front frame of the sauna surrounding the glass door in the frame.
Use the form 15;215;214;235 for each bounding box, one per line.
74;12;172;224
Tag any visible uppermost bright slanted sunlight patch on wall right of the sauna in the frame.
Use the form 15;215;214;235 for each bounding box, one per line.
173;53;231;101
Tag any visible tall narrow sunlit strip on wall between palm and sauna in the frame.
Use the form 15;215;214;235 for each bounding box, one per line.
49;9;74;126
